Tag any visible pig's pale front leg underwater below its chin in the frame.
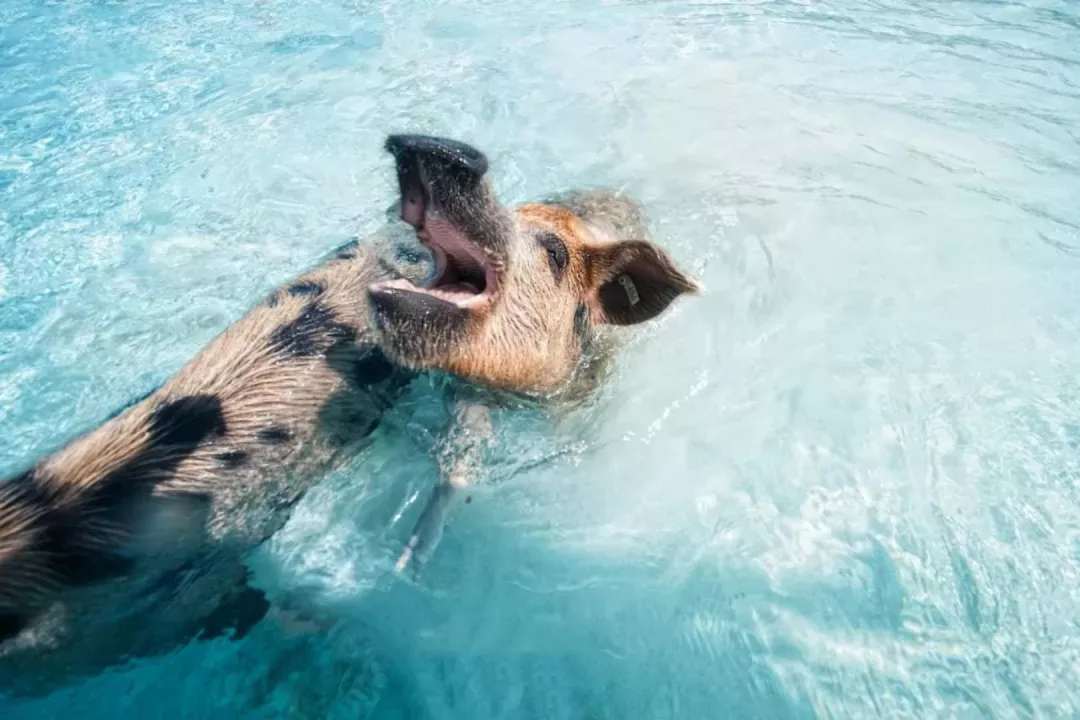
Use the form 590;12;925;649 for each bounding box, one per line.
395;400;491;572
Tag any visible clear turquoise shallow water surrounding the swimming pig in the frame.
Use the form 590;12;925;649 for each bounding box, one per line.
0;0;1080;720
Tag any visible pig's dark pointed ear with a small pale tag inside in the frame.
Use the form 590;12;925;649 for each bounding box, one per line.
589;240;701;325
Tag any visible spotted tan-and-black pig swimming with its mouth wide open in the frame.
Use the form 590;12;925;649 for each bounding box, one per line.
0;135;697;692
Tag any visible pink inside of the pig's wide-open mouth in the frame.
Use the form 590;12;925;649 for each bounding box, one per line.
372;211;499;308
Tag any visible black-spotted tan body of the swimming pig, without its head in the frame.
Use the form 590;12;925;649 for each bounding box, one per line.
0;223;430;692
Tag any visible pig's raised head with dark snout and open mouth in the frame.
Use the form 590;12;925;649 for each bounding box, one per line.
368;135;699;395
